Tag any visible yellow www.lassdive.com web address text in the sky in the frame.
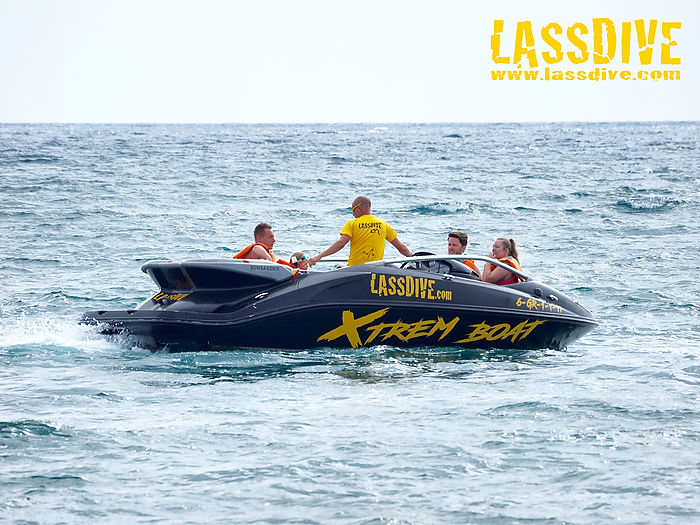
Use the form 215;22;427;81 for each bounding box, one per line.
491;67;681;82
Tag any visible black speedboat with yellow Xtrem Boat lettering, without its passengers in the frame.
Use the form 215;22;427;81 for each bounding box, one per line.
81;254;596;351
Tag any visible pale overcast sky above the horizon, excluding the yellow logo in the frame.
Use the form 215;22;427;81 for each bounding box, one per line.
0;0;700;122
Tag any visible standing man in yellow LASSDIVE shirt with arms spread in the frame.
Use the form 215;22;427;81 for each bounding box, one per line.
309;195;411;266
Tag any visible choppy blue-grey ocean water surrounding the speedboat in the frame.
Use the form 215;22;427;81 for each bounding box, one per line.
0;123;700;524
